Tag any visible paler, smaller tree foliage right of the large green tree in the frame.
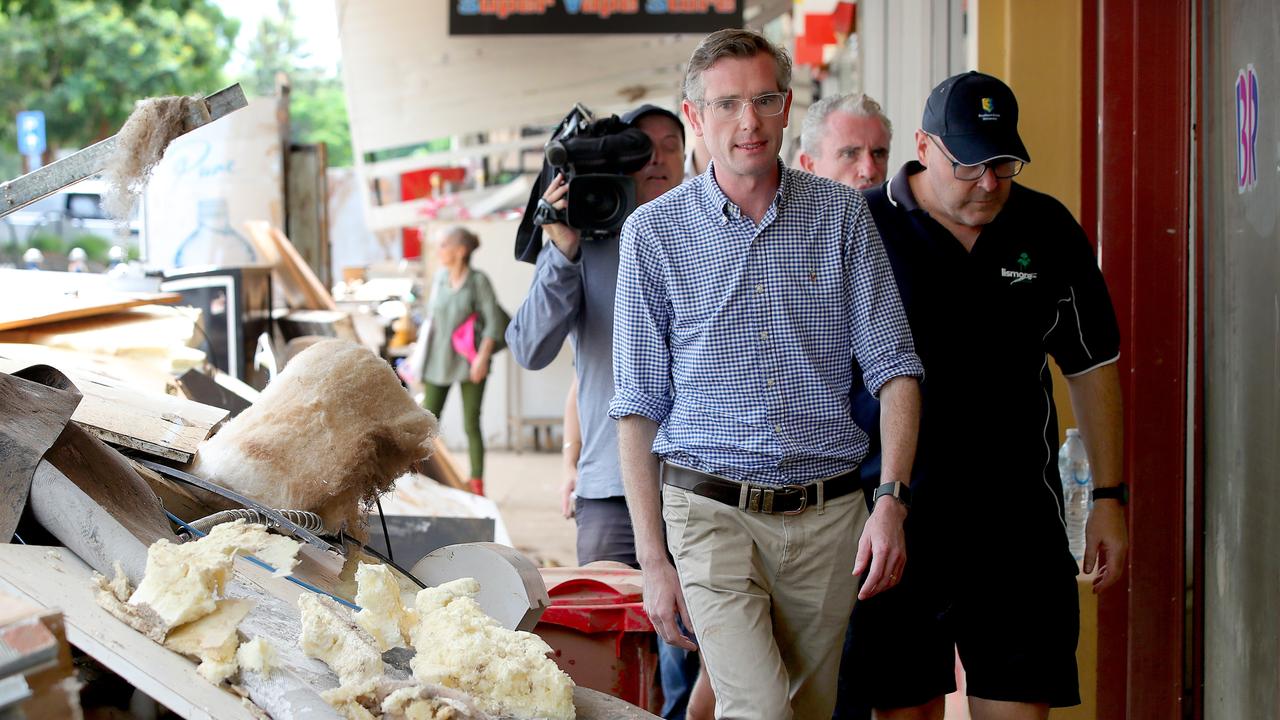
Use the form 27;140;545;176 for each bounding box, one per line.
241;0;352;167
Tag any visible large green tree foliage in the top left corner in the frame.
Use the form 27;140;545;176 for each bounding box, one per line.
0;0;239;177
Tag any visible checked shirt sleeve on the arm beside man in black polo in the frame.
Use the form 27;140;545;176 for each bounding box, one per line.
846;202;924;397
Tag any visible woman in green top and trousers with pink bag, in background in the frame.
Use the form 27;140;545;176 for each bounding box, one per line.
422;227;508;495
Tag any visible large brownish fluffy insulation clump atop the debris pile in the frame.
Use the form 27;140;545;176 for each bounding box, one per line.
192;340;435;533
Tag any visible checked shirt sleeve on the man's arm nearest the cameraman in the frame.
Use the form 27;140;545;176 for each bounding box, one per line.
609;215;673;424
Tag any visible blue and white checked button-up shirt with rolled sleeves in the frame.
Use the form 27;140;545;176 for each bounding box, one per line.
609;161;924;486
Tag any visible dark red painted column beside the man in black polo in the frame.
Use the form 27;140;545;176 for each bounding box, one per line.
1083;0;1193;719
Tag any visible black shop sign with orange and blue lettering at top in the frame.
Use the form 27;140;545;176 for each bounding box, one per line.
449;0;745;35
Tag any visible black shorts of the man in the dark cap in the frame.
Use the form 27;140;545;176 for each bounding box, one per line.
841;520;1080;708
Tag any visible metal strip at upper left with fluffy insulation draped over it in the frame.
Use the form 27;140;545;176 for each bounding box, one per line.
0;83;248;218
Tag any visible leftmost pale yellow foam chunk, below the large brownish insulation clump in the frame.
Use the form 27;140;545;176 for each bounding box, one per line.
129;520;298;630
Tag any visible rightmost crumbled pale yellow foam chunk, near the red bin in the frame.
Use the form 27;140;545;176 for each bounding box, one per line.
410;578;575;720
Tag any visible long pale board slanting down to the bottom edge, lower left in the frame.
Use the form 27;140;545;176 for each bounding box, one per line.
0;544;262;720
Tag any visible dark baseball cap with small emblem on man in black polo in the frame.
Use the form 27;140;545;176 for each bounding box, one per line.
920;70;1032;165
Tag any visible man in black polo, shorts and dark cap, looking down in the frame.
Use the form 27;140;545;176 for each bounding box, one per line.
842;72;1128;720
